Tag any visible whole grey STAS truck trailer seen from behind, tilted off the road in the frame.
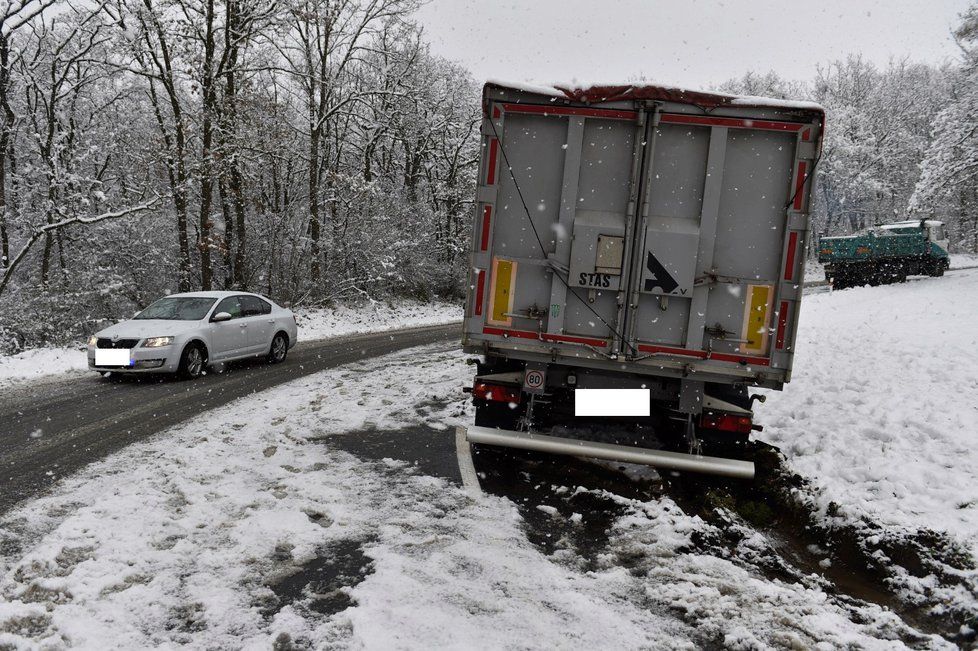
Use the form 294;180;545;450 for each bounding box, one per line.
460;82;824;477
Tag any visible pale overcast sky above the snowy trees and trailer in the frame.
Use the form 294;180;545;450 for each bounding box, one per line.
418;0;970;87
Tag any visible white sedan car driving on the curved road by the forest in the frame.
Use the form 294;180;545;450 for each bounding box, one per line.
88;292;297;378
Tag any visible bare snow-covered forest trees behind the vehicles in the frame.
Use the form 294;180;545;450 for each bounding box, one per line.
0;0;978;354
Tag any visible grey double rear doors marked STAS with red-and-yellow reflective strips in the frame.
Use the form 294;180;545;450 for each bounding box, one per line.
465;81;820;383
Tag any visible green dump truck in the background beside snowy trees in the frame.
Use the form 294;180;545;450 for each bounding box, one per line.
818;219;950;289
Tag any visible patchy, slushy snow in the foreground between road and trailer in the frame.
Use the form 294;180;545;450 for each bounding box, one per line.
0;346;942;649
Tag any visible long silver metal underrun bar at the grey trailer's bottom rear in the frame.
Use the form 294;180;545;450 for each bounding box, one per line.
465;427;754;479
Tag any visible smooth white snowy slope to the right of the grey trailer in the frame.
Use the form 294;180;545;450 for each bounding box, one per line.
757;270;978;610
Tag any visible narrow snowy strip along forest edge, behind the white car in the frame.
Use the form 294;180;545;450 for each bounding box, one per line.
0;300;462;388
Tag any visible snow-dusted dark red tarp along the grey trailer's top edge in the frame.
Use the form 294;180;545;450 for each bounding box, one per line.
483;79;825;119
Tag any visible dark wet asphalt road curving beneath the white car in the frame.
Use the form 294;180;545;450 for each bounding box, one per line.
0;323;461;513
